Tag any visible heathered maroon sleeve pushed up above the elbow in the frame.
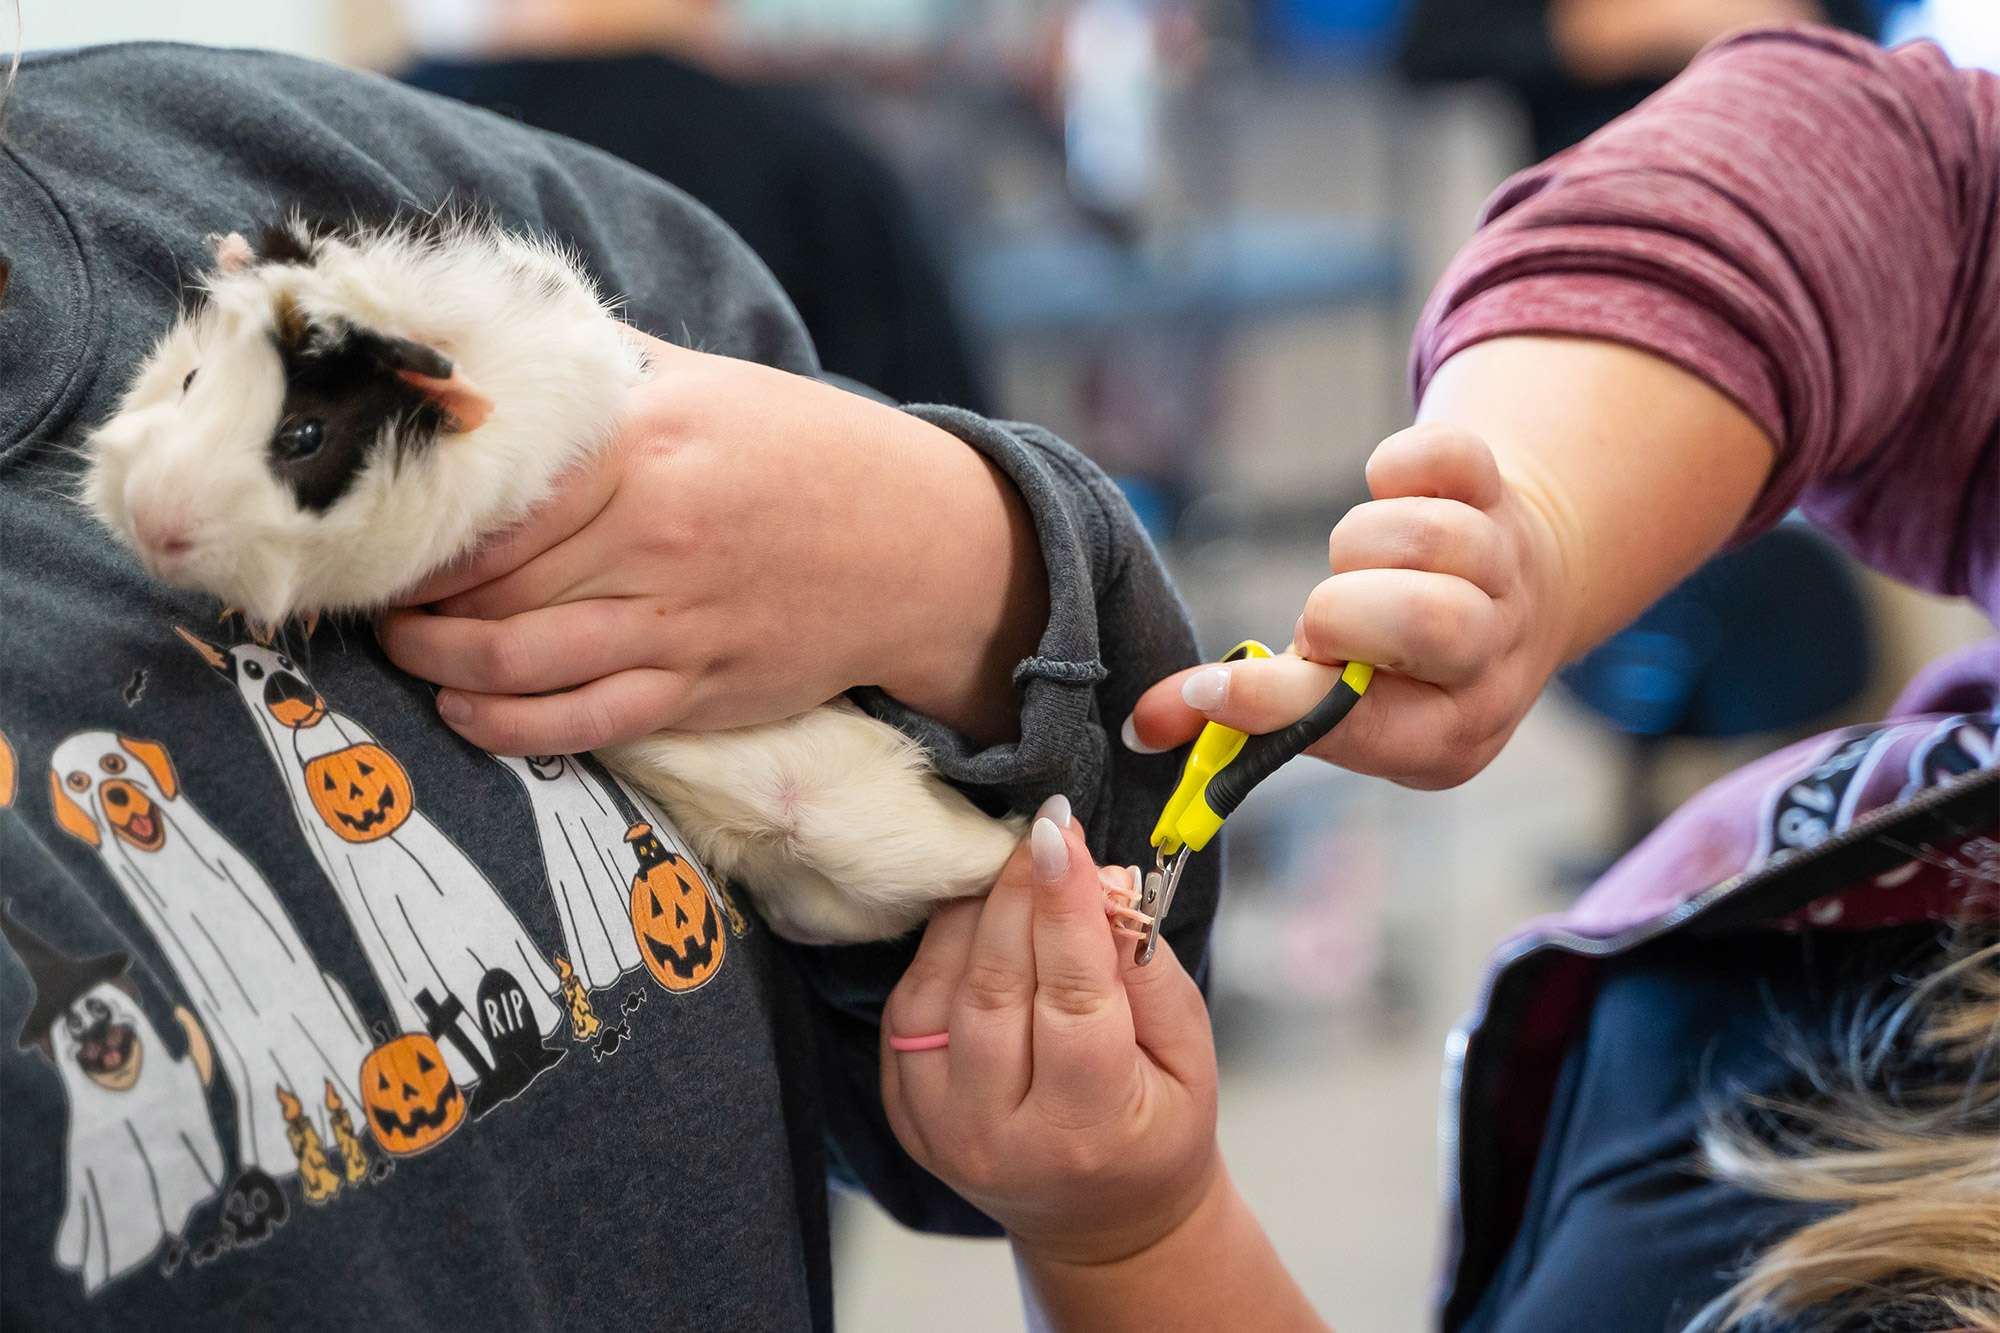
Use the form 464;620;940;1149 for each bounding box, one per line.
1414;26;2000;610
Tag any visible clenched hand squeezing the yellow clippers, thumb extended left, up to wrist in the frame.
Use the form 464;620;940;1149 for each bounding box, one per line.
1126;424;1572;787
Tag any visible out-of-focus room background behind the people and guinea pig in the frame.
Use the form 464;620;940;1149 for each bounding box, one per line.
22;0;2000;1333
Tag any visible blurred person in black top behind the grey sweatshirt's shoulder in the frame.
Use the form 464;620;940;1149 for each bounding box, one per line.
400;0;992;412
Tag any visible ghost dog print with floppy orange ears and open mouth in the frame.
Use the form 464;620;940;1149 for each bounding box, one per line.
48;731;370;1181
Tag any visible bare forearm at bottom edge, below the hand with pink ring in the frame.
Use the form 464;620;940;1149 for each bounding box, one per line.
1016;1167;1326;1333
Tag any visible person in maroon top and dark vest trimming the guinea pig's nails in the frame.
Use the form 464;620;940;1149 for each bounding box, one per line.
882;26;2000;1333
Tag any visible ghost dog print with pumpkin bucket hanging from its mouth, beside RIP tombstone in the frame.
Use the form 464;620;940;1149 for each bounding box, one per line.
176;626;564;1104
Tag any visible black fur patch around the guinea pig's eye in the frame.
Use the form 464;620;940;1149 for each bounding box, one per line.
270;320;444;514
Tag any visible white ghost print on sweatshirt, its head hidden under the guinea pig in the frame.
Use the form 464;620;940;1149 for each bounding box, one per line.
494;755;640;991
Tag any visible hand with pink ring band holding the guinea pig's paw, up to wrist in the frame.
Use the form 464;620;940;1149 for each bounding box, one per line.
882;799;1226;1265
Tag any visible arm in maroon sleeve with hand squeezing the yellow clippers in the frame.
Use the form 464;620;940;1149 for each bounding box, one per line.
1134;28;2000;787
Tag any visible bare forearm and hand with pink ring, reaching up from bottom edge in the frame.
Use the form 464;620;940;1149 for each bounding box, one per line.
882;803;1324;1333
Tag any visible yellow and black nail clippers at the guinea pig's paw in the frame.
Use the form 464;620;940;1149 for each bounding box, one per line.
1132;638;1374;967
